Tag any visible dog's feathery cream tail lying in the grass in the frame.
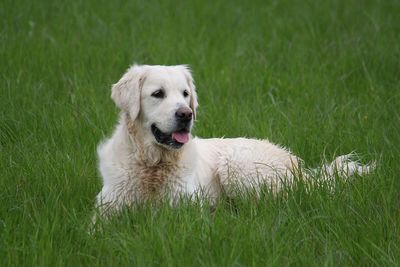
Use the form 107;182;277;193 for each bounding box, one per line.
310;152;376;179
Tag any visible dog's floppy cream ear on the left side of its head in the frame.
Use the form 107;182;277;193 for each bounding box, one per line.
111;65;146;120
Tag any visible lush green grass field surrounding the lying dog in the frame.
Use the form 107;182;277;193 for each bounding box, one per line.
0;0;400;266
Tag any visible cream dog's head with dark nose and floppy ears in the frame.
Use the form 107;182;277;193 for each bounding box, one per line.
111;65;197;148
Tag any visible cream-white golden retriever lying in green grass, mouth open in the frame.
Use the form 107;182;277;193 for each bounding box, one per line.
97;65;372;218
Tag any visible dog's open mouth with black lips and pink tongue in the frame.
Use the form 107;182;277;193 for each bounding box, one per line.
151;124;190;149
